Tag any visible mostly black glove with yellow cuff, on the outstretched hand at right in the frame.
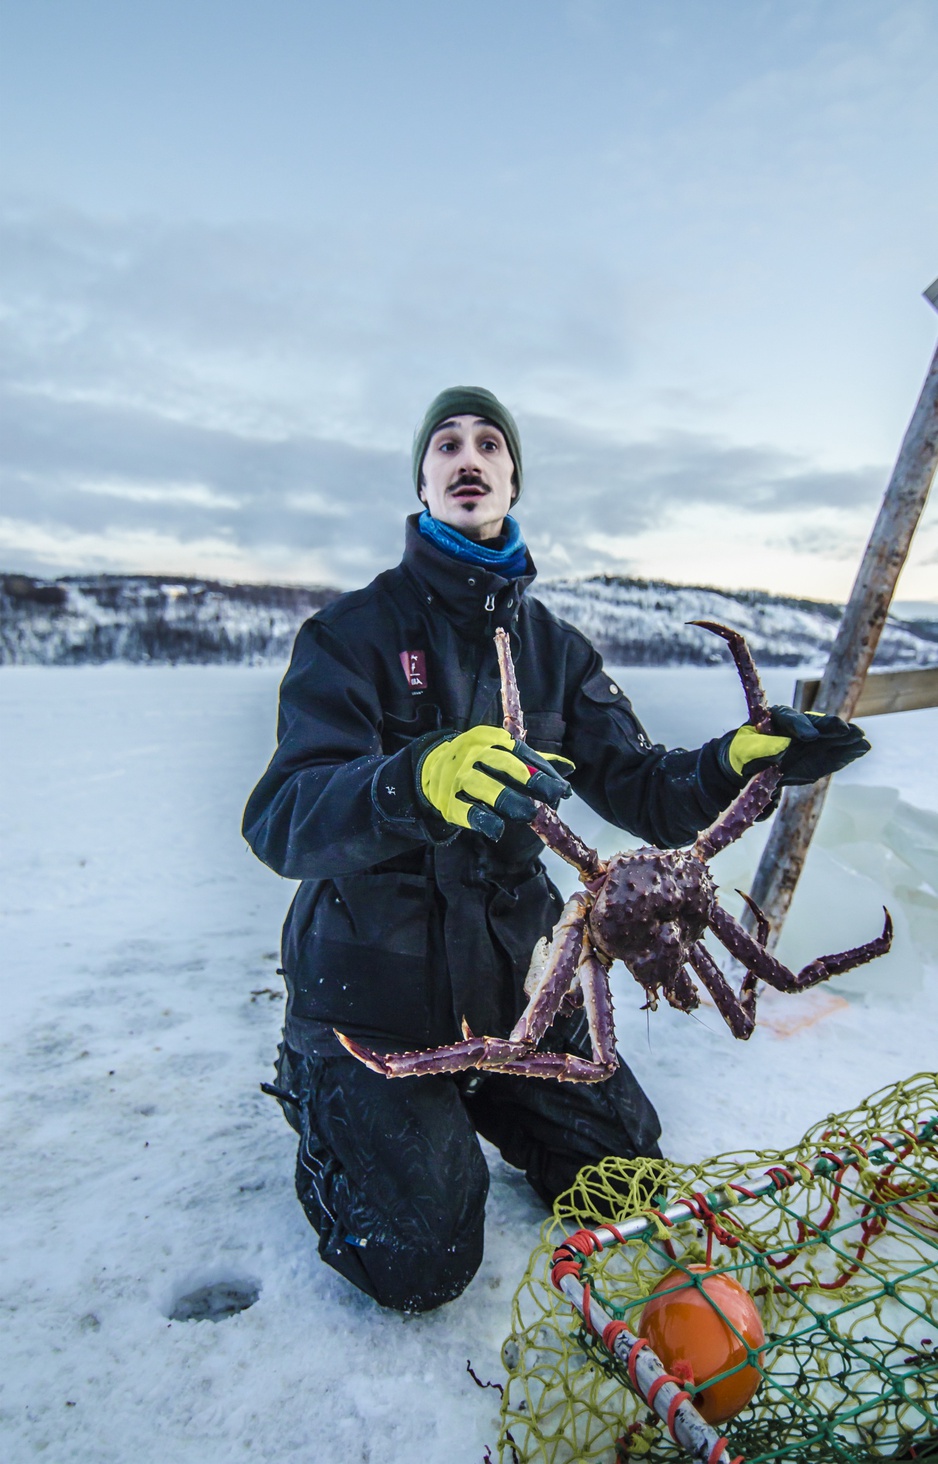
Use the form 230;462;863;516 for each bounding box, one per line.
720;706;869;788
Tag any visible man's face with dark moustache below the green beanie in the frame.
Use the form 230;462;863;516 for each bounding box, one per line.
420;416;515;542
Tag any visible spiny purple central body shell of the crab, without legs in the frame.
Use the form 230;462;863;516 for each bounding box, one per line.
588;849;716;991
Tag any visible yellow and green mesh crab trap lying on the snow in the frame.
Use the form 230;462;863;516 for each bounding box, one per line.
499;1073;938;1464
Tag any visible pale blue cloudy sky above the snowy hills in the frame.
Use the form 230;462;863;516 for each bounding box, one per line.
0;0;938;600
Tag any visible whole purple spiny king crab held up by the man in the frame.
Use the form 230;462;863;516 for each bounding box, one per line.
337;621;893;1083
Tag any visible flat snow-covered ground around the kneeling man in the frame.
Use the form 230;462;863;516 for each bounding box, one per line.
0;665;938;1464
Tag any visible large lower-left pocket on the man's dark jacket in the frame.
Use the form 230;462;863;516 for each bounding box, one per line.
291;871;432;1045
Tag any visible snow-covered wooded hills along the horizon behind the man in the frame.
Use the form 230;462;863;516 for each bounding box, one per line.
0;574;938;668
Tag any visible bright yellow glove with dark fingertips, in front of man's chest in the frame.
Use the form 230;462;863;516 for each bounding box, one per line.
417;726;574;840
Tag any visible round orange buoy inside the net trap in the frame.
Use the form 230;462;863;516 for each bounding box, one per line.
639;1265;765;1423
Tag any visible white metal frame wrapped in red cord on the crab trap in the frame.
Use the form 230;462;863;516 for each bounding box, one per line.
550;1118;938;1464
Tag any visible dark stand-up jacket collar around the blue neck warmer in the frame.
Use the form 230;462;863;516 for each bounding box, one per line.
401;514;537;631
